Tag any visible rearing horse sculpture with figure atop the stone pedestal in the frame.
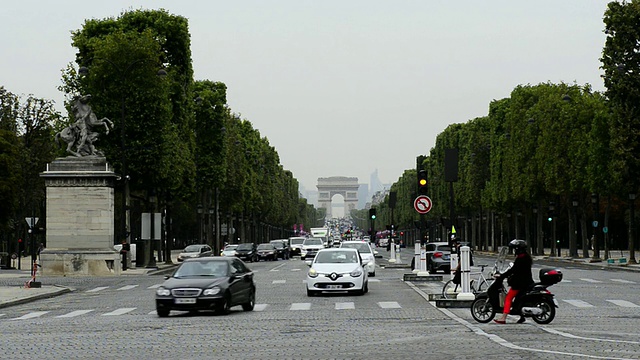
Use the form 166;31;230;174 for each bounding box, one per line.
55;94;113;157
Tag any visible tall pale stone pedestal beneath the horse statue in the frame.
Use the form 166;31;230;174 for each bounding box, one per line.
40;156;121;275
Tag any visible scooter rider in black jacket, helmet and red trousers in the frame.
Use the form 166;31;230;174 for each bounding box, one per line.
493;239;534;324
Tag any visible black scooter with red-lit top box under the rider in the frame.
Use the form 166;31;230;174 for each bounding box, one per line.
471;248;562;324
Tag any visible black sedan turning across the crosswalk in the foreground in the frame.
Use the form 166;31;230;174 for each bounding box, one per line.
156;257;256;317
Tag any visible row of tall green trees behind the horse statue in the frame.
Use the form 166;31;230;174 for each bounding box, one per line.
0;10;317;251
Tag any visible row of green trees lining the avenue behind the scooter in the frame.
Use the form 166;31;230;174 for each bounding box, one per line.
360;1;640;262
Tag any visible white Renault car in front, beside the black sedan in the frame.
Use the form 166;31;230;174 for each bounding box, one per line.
306;248;369;296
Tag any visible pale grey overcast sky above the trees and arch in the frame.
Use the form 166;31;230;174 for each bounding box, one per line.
0;0;608;194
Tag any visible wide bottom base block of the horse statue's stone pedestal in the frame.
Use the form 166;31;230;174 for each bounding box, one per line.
40;249;122;276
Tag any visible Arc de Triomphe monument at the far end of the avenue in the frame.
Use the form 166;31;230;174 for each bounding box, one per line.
317;176;360;218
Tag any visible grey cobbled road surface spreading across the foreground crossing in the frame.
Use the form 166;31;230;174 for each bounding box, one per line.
0;253;640;360
